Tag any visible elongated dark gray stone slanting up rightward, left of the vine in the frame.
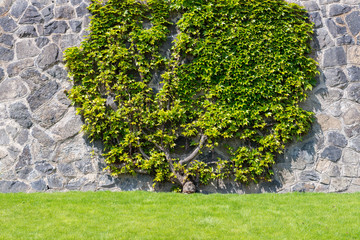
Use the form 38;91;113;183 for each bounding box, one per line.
27;81;59;111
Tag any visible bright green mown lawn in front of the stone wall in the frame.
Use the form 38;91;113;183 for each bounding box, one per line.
0;192;360;240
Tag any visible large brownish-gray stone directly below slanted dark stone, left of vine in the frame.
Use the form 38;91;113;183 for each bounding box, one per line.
33;101;67;128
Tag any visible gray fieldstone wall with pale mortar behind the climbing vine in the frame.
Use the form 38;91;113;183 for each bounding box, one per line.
0;0;360;193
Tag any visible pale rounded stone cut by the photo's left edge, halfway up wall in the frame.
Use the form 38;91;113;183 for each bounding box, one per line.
0;78;28;101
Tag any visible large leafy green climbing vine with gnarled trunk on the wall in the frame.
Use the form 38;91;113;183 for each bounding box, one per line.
65;0;317;193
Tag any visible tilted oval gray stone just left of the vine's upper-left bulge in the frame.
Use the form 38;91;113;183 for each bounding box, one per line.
36;43;61;70
